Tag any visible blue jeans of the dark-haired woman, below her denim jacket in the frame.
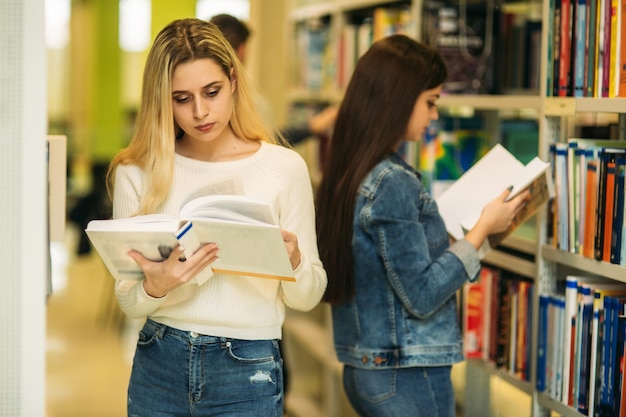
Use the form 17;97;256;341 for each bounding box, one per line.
343;365;455;417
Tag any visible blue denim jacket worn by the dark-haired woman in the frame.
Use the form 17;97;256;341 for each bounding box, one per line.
332;154;480;369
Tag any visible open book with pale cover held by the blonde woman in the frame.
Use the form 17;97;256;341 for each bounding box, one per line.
85;195;295;284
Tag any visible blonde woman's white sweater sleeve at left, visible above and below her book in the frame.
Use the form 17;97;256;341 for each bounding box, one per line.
113;165;167;318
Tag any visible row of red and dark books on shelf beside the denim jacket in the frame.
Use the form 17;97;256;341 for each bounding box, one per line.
463;265;534;381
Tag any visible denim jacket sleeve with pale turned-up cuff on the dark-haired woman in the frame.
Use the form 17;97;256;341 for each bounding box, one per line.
355;169;480;318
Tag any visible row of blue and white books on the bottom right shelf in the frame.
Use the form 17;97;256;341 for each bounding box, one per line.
537;275;626;417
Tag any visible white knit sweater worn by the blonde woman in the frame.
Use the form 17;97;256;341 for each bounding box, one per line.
113;143;326;340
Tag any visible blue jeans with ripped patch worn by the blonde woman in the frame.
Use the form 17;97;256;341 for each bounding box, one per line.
128;319;284;417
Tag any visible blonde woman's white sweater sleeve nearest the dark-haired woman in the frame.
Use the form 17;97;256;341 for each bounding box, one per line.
279;151;327;311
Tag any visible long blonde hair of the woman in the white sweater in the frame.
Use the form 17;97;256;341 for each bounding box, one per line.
107;19;285;214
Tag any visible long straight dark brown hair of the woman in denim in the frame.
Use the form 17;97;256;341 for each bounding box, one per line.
316;35;447;304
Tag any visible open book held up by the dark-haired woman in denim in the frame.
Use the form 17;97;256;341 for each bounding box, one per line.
437;144;554;258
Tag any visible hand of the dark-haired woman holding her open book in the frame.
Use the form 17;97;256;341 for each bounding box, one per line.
465;189;530;249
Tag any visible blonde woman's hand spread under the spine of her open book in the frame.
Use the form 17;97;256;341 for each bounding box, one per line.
128;243;219;298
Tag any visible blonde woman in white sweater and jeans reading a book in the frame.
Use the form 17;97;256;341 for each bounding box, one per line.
109;19;326;417
